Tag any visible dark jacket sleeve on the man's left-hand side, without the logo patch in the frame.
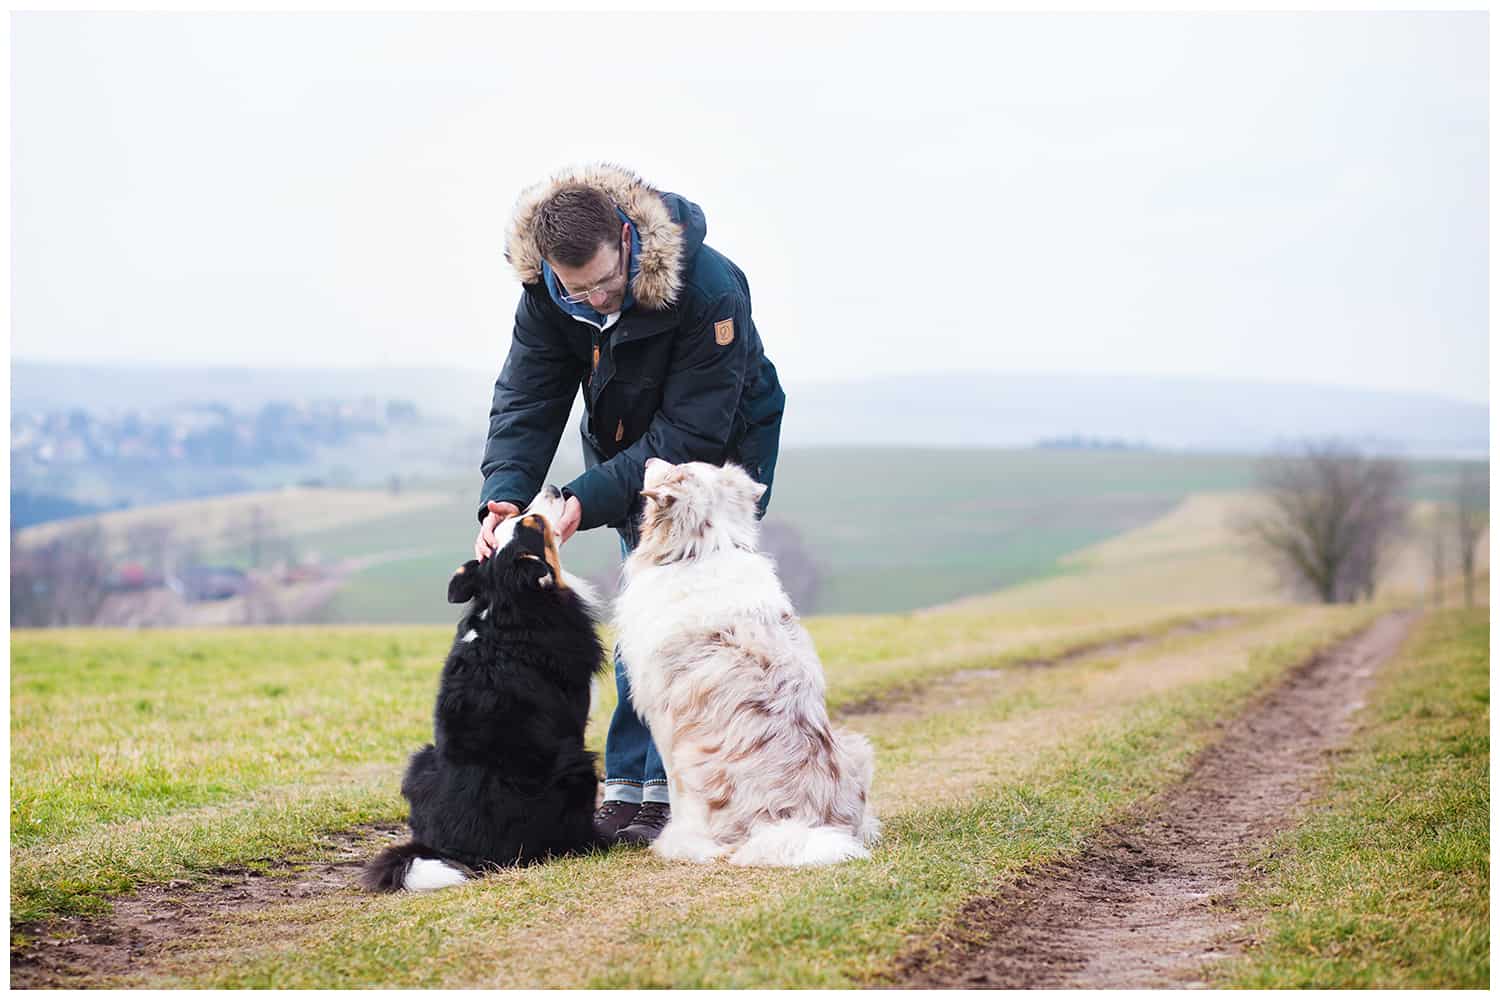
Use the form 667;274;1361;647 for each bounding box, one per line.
479;292;587;520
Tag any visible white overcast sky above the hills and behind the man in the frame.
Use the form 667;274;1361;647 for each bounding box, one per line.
12;13;1488;402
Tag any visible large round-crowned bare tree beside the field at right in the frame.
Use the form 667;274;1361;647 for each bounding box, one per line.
1241;441;1407;604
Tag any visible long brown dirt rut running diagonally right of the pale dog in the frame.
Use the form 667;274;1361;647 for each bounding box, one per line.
896;613;1415;988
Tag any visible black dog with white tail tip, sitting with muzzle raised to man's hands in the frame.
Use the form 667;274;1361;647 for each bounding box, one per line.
362;486;605;892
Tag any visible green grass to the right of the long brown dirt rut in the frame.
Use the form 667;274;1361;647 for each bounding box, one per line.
1218;609;1490;990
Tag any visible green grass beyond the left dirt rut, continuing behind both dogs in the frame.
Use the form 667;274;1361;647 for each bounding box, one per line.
11;599;1206;919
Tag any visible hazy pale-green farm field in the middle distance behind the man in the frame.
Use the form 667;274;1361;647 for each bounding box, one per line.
23;448;1476;624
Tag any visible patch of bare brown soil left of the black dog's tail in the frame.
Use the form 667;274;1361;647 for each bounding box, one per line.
11;823;407;990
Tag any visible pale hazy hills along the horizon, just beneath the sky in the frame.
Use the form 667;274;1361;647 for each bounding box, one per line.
11;357;1490;455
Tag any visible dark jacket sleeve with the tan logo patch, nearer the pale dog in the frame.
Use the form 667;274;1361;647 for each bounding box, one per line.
563;294;750;531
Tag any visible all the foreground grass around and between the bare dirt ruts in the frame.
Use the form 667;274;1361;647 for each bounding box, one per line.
11;455;1488;987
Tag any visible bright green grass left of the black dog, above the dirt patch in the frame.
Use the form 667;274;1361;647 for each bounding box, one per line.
11;628;446;847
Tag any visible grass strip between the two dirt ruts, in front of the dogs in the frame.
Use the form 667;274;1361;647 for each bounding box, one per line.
149;609;1370;988
